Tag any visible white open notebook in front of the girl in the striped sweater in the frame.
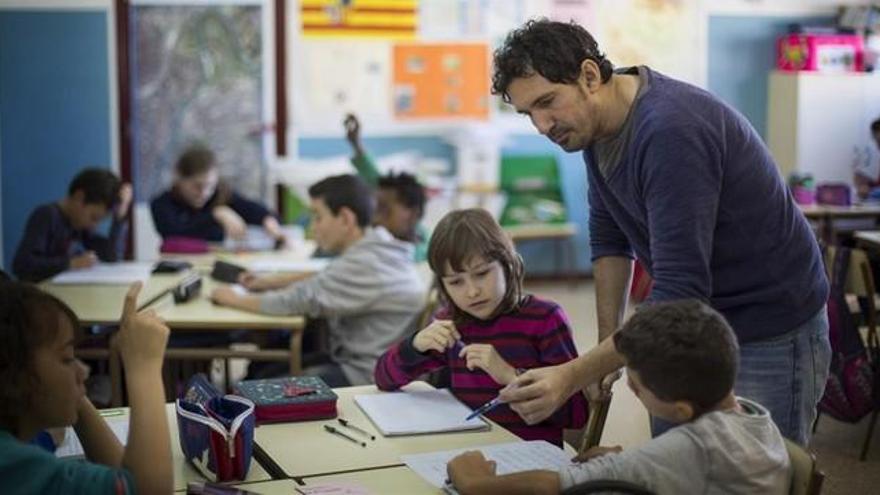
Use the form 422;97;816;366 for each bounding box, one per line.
354;389;489;437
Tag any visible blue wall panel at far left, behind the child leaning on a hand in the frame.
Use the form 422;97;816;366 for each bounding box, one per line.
0;10;111;268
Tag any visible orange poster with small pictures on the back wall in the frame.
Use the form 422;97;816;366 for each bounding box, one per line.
394;43;489;119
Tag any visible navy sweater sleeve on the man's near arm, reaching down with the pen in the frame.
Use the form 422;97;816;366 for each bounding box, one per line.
639;126;723;301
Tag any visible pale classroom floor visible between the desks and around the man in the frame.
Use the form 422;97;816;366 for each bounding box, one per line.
526;280;880;495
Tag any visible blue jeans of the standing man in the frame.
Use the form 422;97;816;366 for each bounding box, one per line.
651;306;831;445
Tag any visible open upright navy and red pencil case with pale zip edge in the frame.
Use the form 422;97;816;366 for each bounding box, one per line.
176;373;256;481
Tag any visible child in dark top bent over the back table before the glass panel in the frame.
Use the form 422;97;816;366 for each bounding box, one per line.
150;146;285;243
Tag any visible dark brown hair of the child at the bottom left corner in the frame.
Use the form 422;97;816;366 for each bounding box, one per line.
0;282;80;435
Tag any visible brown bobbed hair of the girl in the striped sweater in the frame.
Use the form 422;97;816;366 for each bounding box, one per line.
428;208;524;326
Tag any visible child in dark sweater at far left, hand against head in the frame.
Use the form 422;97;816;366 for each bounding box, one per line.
12;168;132;282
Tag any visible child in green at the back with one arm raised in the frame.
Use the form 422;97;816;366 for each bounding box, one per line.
344;114;429;262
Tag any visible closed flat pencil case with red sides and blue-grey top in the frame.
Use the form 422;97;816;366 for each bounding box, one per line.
235;376;338;424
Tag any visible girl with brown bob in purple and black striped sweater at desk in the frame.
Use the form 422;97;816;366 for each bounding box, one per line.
374;209;587;445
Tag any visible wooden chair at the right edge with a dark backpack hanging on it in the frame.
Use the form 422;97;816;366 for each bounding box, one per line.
813;247;880;461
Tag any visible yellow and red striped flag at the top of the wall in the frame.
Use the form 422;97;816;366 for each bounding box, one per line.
300;0;418;40
